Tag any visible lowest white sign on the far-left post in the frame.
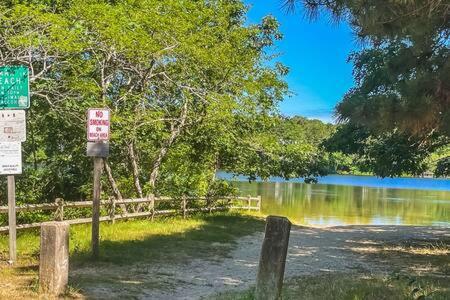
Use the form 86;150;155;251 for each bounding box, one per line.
0;142;22;175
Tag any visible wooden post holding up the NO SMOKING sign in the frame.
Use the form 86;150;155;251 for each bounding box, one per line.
92;156;103;258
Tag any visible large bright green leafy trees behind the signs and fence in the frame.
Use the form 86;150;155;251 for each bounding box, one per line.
0;0;294;203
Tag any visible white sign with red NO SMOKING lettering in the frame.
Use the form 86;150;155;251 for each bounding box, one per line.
87;108;111;142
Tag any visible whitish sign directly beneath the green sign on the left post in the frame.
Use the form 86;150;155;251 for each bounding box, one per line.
0;110;27;142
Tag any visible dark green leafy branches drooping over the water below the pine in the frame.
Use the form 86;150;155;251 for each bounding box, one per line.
323;123;442;177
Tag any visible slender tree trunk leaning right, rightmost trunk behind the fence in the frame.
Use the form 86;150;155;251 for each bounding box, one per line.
148;100;188;189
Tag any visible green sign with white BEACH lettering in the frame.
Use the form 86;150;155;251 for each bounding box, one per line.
0;66;30;109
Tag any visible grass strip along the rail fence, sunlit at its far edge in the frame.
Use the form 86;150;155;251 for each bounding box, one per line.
70;213;264;264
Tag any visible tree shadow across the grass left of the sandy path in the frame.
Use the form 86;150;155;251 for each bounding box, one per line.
70;215;264;298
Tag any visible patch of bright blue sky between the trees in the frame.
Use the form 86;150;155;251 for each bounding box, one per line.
245;0;358;122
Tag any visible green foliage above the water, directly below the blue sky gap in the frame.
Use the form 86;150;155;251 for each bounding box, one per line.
221;117;334;180
